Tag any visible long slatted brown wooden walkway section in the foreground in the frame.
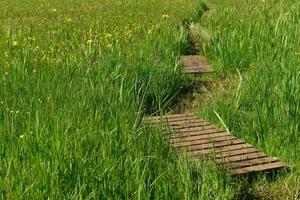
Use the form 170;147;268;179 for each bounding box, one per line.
144;113;286;175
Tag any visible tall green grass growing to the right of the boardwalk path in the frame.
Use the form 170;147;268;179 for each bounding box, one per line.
198;0;300;199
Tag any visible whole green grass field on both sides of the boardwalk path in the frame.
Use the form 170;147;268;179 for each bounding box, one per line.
0;0;300;199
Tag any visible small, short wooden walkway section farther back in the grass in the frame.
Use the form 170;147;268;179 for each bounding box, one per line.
180;55;213;74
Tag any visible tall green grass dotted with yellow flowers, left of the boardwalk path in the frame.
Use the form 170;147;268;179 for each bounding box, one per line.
0;0;240;199
